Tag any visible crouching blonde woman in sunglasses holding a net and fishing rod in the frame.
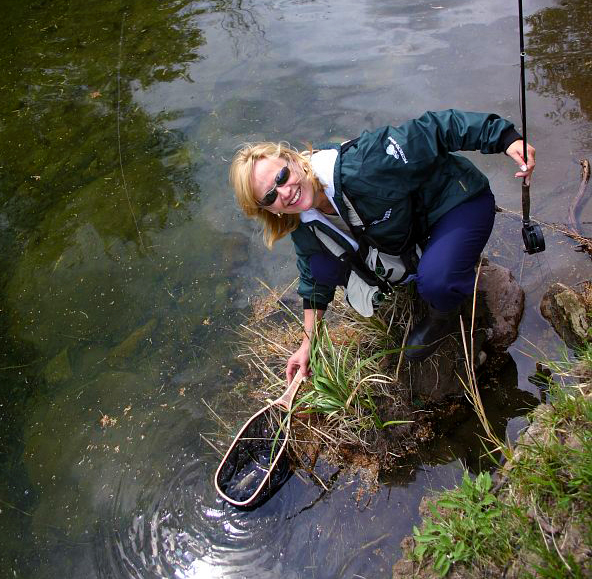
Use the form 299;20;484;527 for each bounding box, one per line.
230;109;535;381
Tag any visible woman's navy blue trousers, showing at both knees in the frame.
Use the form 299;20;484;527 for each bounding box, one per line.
310;189;495;312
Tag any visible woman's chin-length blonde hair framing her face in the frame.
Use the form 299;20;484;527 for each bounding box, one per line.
229;141;323;249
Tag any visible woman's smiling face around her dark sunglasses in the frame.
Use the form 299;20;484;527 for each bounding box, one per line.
252;157;317;214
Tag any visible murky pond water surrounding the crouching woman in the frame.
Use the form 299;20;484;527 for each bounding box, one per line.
0;0;592;579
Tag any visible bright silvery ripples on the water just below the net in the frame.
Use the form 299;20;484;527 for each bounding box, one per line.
95;438;302;579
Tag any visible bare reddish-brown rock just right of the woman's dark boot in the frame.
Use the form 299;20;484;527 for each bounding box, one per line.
477;265;524;352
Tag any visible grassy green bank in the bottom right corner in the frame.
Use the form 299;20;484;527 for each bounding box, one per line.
411;354;592;577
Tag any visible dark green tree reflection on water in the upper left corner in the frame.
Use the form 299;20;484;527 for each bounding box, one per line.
0;2;208;357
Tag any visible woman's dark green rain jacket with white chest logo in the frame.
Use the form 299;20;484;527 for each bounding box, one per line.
291;109;522;309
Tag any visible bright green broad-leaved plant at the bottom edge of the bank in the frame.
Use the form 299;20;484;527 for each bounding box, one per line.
413;473;503;577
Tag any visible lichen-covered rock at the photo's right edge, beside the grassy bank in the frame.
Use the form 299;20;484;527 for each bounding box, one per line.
540;283;590;348
